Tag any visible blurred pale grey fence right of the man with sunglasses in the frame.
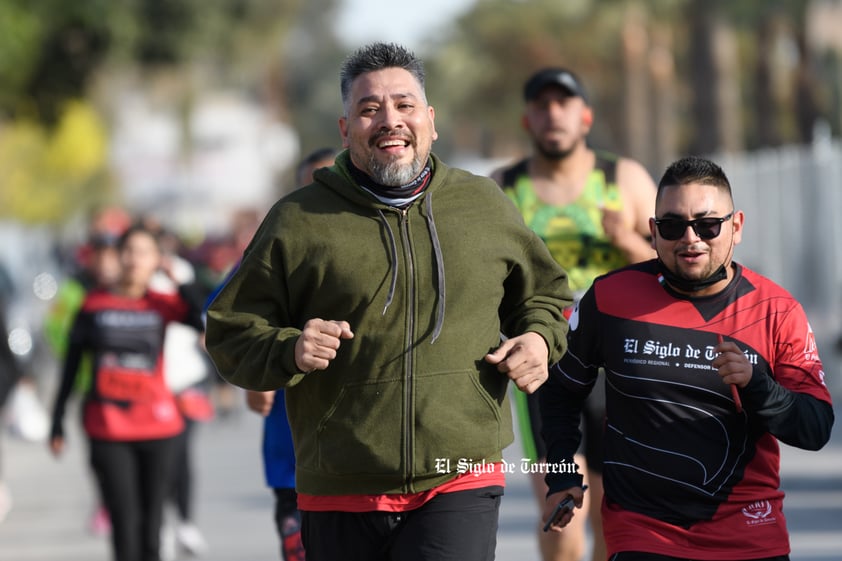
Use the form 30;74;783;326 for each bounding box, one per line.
716;138;842;328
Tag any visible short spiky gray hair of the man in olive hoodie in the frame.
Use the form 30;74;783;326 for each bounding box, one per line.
339;43;427;116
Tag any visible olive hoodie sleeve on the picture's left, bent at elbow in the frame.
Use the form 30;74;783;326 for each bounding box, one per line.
205;240;304;391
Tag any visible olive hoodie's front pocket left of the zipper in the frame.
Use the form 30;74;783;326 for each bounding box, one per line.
316;381;403;475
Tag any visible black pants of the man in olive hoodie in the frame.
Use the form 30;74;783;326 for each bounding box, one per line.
301;486;503;561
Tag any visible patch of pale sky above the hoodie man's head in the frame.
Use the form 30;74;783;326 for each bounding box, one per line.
335;0;475;50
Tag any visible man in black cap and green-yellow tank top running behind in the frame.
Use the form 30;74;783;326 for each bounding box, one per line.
492;68;655;561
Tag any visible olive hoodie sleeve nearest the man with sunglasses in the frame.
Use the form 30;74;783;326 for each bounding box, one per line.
500;230;573;364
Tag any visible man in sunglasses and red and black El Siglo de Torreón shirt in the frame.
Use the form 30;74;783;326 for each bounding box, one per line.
541;157;834;561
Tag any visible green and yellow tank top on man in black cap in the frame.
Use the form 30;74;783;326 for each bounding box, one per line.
503;153;628;295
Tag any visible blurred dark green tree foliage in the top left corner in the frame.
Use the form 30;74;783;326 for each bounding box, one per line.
0;0;302;120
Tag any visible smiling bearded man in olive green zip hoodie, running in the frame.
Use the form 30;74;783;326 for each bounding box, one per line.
207;43;571;561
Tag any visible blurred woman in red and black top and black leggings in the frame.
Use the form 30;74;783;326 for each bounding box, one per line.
50;226;202;561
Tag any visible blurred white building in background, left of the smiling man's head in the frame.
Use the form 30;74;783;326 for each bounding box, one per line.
111;91;300;236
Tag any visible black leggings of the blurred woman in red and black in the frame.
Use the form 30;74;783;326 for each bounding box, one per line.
90;437;179;561
